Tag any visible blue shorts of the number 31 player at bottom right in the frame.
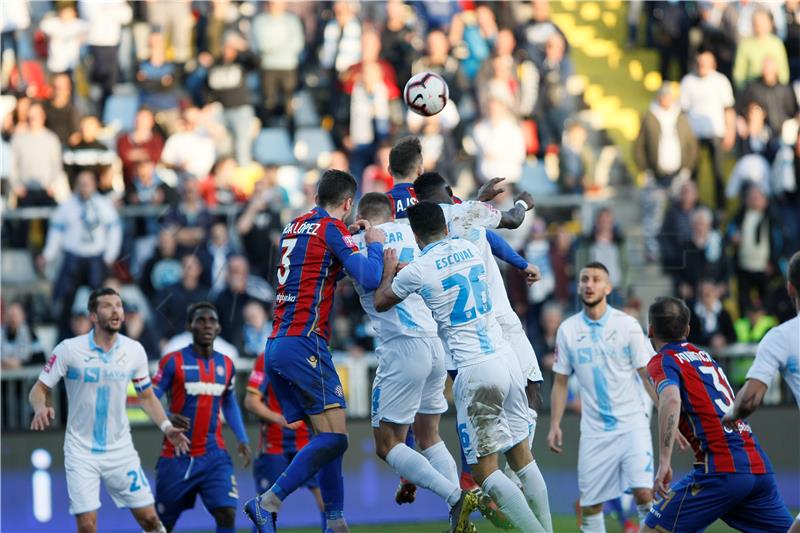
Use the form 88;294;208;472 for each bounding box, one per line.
645;470;793;533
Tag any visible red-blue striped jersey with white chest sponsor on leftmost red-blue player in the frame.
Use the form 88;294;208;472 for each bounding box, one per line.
153;345;236;457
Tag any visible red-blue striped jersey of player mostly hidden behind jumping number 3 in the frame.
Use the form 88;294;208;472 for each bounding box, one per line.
247;354;311;455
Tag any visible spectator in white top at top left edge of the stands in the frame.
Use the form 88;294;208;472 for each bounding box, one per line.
39;2;89;77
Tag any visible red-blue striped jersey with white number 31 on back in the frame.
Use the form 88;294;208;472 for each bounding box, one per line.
647;342;772;474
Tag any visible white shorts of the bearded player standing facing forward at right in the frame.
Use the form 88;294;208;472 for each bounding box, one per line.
578;428;653;507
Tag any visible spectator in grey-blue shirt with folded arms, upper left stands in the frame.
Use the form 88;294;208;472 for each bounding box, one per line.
136;32;179;112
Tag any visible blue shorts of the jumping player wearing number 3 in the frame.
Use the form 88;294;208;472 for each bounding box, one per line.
265;335;346;423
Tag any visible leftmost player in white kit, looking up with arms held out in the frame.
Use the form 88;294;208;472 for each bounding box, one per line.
30;288;189;533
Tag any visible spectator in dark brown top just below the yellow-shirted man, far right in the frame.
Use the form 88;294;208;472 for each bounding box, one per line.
739;57;797;135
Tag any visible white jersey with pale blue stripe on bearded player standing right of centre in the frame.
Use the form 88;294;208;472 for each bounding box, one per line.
553;306;655;436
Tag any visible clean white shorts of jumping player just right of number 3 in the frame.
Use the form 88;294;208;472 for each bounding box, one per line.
372;337;447;428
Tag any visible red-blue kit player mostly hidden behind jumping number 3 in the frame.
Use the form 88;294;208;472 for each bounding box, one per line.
244;354;326;531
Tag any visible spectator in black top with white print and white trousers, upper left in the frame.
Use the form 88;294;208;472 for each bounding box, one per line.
199;32;258;166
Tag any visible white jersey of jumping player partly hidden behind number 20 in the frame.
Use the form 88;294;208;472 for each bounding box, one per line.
439;201;516;317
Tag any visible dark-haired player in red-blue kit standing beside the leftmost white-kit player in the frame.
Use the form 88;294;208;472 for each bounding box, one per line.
153;302;250;533
